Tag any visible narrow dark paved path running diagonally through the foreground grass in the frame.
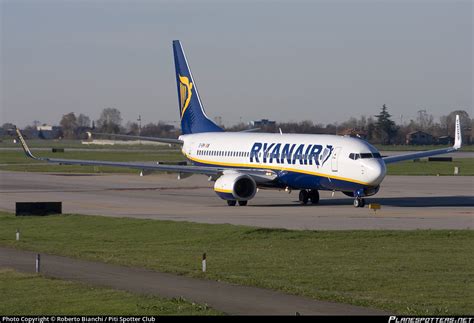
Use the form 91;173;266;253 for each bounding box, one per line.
0;247;387;315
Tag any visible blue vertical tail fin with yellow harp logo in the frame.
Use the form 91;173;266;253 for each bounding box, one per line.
173;40;224;134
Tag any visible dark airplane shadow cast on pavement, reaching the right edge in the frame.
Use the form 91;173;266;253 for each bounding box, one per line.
254;196;474;207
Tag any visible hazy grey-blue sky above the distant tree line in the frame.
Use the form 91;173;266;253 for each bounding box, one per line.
0;0;474;127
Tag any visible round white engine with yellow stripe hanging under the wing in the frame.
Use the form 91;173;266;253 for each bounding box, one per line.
214;173;257;201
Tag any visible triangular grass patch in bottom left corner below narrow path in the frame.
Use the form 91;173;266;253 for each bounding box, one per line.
0;269;218;315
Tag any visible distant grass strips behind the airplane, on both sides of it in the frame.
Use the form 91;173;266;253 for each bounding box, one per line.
0;150;474;176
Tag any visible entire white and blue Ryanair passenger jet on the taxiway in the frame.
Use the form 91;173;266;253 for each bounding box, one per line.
17;40;461;207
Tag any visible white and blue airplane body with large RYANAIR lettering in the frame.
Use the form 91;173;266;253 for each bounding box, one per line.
180;132;386;196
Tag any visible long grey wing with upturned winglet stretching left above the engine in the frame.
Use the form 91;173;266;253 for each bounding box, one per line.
16;129;277;183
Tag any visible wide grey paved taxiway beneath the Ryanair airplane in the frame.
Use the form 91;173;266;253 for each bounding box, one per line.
0;172;474;230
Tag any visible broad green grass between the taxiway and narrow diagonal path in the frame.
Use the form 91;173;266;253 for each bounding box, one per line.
0;213;474;315
